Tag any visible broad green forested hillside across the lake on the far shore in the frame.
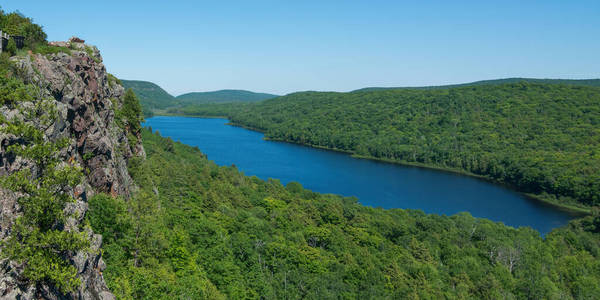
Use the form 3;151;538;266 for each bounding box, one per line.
178;82;600;211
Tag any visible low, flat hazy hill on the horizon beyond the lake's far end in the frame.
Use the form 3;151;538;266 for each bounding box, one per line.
176;90;279;104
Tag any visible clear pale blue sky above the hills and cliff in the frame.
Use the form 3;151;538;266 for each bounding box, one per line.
0;0;600;95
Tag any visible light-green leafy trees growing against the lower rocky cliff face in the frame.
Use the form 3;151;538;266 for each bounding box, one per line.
0;112;89;293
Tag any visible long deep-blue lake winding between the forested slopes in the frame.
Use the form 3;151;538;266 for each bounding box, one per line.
144;117;577;234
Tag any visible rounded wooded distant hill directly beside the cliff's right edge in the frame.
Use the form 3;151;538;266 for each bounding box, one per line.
121;79;177;110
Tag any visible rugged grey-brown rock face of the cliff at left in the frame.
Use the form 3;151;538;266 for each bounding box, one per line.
0;42;145;299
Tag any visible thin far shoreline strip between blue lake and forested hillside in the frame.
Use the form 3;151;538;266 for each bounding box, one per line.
149;114;591;215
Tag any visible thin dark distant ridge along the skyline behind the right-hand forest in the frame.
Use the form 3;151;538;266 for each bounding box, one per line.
352;77;600;92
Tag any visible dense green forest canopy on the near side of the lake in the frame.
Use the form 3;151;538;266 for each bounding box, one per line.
88;130;600;299
